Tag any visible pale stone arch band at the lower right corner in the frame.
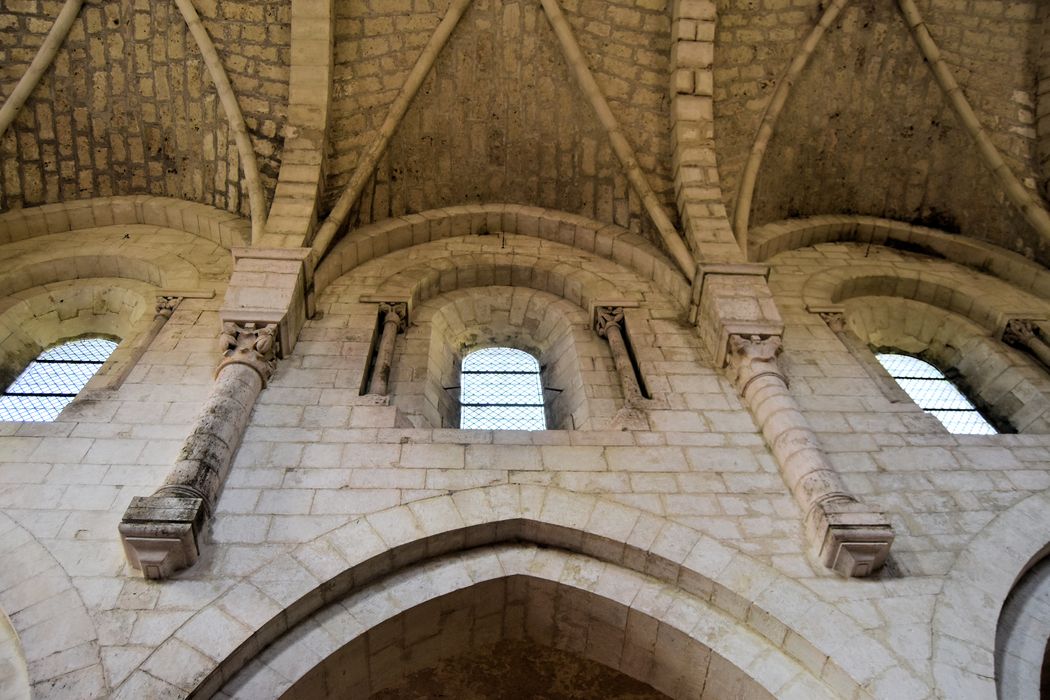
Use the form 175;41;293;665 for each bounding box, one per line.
933;491;1050;699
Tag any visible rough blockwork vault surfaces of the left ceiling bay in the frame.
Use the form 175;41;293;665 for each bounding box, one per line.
0;0;291;213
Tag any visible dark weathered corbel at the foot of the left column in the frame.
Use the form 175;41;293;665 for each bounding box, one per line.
119;495;205;579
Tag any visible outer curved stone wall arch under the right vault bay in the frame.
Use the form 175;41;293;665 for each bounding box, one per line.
748;215;1050;299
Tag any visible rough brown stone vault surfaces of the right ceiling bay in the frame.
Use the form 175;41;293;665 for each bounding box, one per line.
715;0;1048;261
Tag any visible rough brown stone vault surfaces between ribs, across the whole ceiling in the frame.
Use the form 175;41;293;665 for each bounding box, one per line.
0;0;1050;261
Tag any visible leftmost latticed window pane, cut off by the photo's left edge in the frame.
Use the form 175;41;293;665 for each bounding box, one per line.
0;338;118;421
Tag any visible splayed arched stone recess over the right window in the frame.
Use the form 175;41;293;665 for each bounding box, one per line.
843;296;1050;432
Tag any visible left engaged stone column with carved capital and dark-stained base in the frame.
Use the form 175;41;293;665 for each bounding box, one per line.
120;321;277;578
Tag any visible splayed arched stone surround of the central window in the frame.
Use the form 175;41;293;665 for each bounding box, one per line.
391;285;623;429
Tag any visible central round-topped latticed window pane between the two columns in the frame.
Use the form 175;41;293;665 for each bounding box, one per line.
460;347;547;430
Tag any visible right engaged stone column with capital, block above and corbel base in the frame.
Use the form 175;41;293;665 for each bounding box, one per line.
694;266;894;577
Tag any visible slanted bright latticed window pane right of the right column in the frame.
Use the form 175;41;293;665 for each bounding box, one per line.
876;353;999;436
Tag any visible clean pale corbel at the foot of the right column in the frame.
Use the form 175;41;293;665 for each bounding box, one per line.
806;499;894;578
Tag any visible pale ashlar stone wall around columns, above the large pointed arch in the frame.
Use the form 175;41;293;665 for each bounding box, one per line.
0;215;1050;698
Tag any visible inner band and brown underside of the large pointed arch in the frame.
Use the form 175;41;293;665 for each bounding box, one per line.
221;544;814;700
